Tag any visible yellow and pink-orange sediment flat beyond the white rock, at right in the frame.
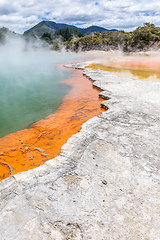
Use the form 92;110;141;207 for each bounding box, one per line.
87;59;160;81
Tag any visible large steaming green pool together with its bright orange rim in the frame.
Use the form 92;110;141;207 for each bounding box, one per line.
0;53;102;180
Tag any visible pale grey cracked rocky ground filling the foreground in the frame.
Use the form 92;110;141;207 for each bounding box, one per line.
0;63;160;240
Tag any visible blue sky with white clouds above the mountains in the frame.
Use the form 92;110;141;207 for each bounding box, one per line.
0;0;160;33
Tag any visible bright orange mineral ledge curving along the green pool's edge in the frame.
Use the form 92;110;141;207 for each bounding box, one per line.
0;67;103;180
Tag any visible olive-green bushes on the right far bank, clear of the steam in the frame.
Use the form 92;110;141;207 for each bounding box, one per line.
66;23;160;52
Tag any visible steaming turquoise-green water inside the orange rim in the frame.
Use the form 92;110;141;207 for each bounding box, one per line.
0;52;84;138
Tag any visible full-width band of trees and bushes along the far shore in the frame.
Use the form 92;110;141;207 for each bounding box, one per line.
0;23;160;52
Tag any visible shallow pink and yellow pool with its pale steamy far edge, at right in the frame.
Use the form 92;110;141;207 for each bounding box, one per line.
87;52;160;81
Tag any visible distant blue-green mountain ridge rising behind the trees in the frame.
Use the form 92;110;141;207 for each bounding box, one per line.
24;21;117;37
